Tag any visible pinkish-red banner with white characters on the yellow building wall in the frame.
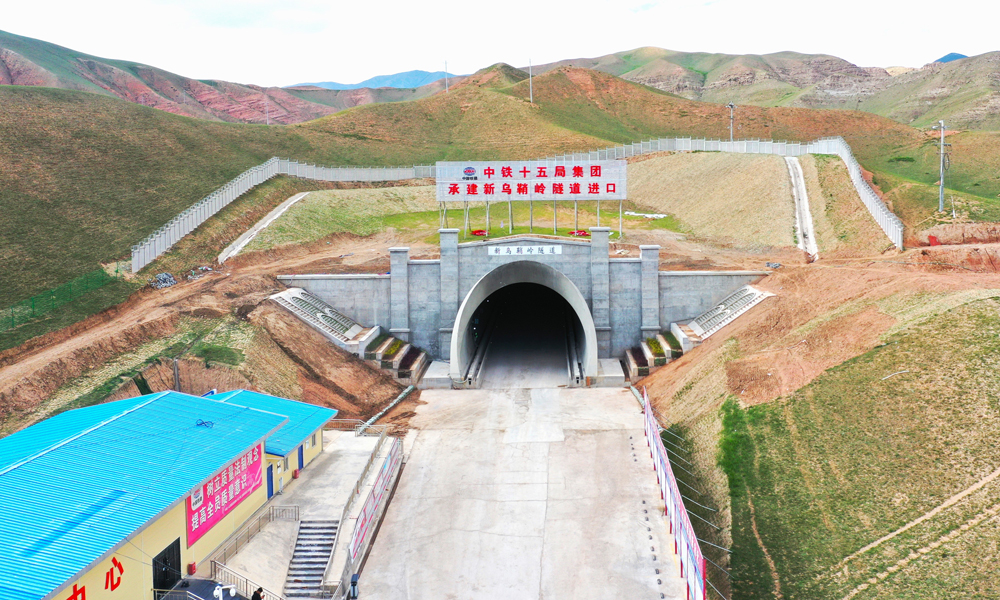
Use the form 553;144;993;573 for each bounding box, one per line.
186;444;264;548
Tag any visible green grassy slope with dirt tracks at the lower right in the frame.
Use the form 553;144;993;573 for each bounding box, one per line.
721;298;1000;600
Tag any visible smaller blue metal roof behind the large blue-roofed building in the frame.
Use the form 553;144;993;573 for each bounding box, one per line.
210;390;337;456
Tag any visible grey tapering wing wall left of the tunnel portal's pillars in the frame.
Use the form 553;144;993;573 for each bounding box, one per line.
278;275;389;329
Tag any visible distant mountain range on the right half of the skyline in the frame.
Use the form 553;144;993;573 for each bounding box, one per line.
534;47;1000;130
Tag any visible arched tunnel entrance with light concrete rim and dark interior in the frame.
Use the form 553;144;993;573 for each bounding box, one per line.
451;261;597;388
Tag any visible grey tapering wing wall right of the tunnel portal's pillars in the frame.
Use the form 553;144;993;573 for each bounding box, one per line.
660;271;767;328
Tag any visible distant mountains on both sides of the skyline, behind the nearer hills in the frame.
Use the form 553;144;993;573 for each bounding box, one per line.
0;31;1000;130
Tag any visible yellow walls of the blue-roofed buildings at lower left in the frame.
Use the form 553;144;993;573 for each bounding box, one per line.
49;462;267;600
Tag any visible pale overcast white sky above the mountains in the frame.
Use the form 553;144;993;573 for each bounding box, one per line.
0;0;1000;86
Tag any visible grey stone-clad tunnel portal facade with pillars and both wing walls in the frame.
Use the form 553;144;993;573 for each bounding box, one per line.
279;227;766;376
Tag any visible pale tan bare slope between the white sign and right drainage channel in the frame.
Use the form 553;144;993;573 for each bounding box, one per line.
628;152;795;248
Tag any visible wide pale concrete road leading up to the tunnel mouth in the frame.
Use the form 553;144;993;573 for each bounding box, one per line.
360;389;684;600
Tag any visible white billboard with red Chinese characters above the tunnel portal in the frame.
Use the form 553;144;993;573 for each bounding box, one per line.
436;160;626;202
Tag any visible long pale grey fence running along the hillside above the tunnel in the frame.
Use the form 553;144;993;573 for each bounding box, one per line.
132;136;903;273
